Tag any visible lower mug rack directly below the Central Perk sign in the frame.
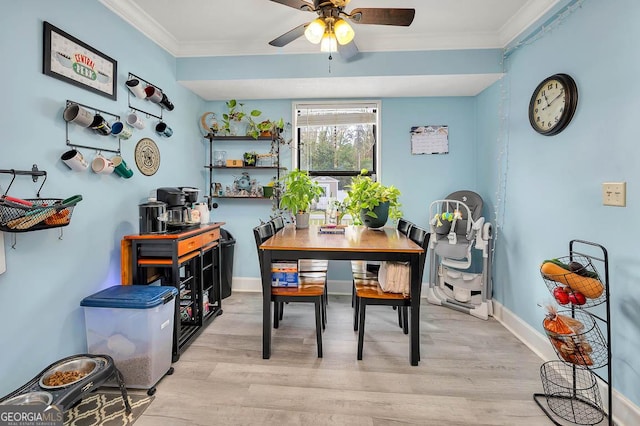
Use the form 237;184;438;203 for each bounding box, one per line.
64;100;121;154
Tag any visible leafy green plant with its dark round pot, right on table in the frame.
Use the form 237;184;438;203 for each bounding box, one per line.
345;169;402;228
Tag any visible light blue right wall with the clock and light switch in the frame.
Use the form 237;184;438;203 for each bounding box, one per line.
477;0;640;404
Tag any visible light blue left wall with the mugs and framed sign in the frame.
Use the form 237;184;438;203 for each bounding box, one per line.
0;0;205;395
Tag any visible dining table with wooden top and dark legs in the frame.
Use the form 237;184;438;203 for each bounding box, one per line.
258;224;426;366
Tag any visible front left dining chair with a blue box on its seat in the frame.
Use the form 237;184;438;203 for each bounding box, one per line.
253;222;326;358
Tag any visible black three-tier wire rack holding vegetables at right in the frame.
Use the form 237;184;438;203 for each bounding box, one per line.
533;240;614;426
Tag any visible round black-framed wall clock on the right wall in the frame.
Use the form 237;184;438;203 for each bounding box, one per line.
529;74;578;136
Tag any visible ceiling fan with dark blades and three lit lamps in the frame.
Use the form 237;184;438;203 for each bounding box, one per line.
269;0;416;59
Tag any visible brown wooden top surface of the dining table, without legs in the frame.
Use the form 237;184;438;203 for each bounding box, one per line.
260;225;423;253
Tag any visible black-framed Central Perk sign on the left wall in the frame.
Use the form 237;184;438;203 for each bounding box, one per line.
42;21;118;101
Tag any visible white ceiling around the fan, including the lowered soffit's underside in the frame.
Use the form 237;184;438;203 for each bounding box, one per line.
100;0;562;100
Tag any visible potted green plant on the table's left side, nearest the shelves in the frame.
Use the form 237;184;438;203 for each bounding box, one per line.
280;169;324;229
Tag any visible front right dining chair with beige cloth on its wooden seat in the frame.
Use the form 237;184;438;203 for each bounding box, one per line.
354;225;431;360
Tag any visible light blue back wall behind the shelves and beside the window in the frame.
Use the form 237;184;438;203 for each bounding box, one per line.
202;97;477;280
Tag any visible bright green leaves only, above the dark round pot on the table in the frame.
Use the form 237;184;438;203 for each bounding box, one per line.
345;169;402;223
